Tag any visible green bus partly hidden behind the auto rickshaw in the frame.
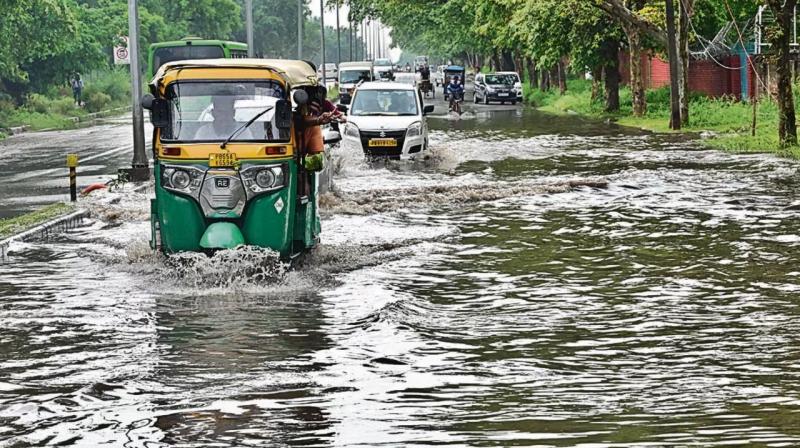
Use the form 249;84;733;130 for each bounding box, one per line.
147;37;247;80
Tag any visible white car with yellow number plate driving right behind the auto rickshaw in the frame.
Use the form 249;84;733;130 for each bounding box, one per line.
341;82;433;160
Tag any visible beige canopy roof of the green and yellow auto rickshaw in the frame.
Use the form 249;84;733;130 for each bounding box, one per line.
150;59;319;88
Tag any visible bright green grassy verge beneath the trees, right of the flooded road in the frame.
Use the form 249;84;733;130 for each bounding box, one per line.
525;80;800;158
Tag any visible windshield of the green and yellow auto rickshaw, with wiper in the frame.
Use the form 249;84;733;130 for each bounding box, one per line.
161;81;289;142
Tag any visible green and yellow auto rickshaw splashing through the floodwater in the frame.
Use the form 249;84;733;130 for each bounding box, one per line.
142;59;339;259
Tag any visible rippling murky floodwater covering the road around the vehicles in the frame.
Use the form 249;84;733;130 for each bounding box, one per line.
0;110;800;447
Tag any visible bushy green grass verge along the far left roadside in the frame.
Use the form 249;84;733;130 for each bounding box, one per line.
0;70;130;138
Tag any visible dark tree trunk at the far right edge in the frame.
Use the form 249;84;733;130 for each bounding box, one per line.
767;0;797;146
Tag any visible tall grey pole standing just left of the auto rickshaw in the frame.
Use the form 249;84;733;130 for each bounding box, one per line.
128;0;150;182
